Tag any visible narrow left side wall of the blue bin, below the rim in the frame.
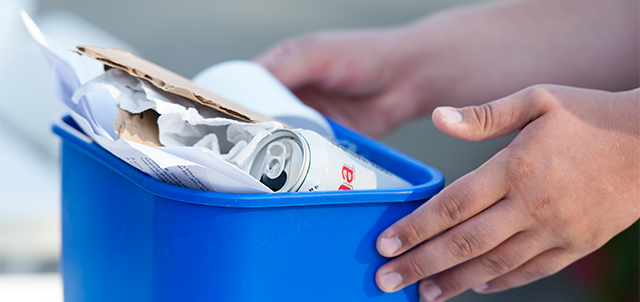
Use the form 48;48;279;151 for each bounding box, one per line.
60;143;154;301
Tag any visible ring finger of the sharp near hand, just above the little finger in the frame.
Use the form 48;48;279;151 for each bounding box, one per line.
419;231;550;301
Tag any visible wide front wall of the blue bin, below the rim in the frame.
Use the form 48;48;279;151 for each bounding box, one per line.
154;201;419;301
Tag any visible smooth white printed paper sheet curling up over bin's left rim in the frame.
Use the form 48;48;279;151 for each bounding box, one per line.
21;12;277;193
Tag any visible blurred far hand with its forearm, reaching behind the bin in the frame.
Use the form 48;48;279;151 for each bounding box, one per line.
256;0;639;137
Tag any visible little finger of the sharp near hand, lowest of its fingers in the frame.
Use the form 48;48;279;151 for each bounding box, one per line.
473;248;583;293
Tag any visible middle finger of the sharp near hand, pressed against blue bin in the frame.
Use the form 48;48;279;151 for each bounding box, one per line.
376;196;528;292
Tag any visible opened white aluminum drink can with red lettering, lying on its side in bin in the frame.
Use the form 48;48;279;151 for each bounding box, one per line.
242;129;411;192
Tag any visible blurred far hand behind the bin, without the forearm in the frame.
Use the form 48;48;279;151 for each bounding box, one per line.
255;28;431;137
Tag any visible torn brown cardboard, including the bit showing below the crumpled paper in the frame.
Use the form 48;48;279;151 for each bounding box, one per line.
76;46;279;146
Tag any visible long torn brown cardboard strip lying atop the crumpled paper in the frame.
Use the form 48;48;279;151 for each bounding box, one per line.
76;46;289;125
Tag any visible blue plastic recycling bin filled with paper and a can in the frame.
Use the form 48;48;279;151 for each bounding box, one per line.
53;116;444;302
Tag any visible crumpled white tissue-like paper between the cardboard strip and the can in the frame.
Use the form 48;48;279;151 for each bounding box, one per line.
72;68;283;167
